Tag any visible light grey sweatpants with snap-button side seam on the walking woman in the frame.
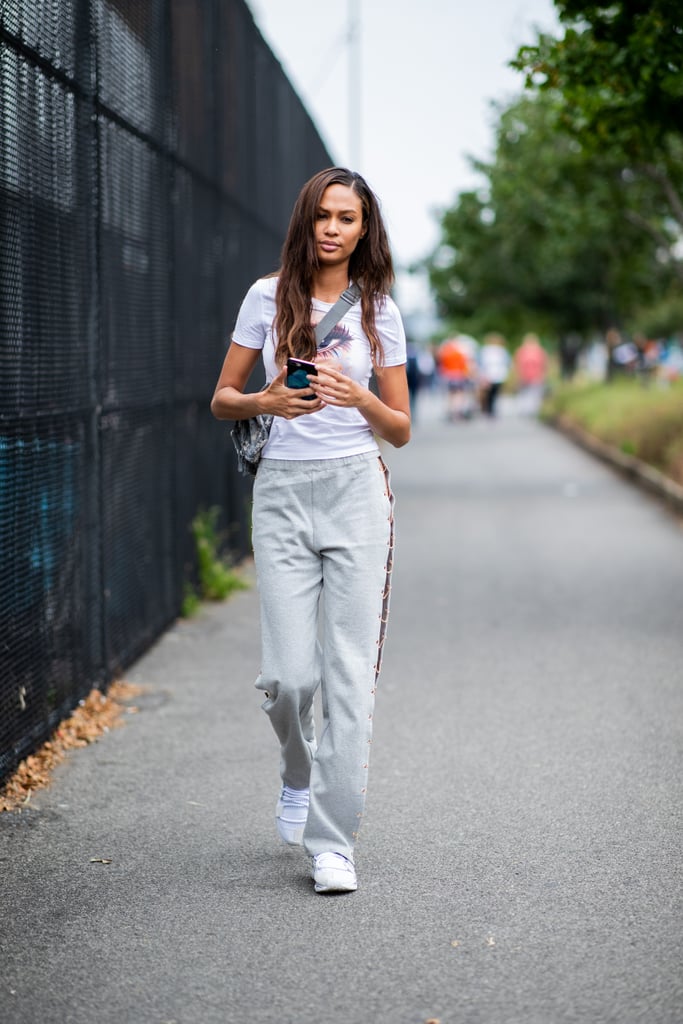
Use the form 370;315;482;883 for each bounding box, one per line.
253;452;393;860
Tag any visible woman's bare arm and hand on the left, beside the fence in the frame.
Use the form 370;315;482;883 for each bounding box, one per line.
211;341;323;420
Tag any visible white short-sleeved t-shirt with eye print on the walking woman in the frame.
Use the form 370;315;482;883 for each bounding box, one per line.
232;278;405;460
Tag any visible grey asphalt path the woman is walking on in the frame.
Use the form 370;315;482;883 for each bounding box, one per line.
0;391;683;1024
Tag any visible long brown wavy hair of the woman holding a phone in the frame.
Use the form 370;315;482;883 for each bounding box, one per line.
273;167;394;367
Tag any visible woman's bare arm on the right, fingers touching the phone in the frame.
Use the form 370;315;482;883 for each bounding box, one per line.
310;362;411;447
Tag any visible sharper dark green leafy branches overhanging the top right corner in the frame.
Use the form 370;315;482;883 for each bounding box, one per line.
512;0;683;280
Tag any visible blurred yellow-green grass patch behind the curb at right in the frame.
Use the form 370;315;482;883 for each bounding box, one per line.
542;380;683;483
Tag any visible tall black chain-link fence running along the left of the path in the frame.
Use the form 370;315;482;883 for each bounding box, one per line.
0;0;330;778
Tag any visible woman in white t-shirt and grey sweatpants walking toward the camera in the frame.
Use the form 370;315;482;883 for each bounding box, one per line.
211;168;411;893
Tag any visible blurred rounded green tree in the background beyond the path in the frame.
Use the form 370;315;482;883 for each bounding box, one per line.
428;90;667;357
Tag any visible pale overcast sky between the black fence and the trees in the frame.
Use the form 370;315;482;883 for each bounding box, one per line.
248;0;558;304
